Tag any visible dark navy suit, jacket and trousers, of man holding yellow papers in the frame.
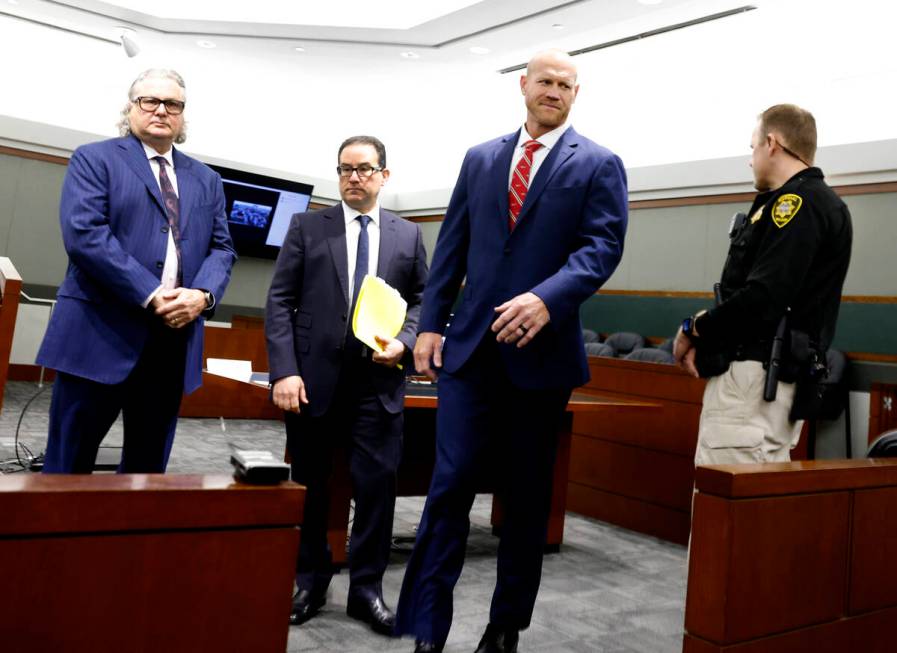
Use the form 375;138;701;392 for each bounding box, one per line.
265;204;427;595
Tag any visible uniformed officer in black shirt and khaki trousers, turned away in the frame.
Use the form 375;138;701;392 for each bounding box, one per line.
673;104;853;465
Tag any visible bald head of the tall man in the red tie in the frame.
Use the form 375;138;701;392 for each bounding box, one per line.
520;50;579;138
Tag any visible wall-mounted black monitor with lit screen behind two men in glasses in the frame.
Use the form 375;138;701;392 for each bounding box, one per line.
209;164;313;259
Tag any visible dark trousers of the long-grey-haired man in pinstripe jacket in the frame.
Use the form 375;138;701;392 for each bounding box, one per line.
44;322;188;474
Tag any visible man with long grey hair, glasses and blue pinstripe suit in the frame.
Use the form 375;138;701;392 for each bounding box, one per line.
37;69;236;473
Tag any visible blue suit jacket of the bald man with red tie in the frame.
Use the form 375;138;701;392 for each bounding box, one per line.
420;127;628;389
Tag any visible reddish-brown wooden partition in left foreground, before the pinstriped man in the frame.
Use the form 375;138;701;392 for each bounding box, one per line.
0;474;305;653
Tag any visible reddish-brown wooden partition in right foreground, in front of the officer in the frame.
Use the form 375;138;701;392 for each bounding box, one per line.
682;459;897;653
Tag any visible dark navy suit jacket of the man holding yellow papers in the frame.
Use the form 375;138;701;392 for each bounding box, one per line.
265;204;427;416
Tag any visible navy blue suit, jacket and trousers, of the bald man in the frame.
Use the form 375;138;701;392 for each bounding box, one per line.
396;128;627;644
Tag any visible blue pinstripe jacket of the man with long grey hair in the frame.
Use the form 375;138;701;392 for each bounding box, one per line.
37;136;236;392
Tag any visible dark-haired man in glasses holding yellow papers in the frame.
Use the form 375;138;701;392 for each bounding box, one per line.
265;136;427;635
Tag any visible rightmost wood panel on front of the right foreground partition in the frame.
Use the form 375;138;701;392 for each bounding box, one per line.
849;487;897;612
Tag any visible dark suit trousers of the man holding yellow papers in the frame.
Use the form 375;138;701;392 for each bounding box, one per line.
285;357;403;595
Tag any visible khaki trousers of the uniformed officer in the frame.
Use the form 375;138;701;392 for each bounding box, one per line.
695;361;803;465
